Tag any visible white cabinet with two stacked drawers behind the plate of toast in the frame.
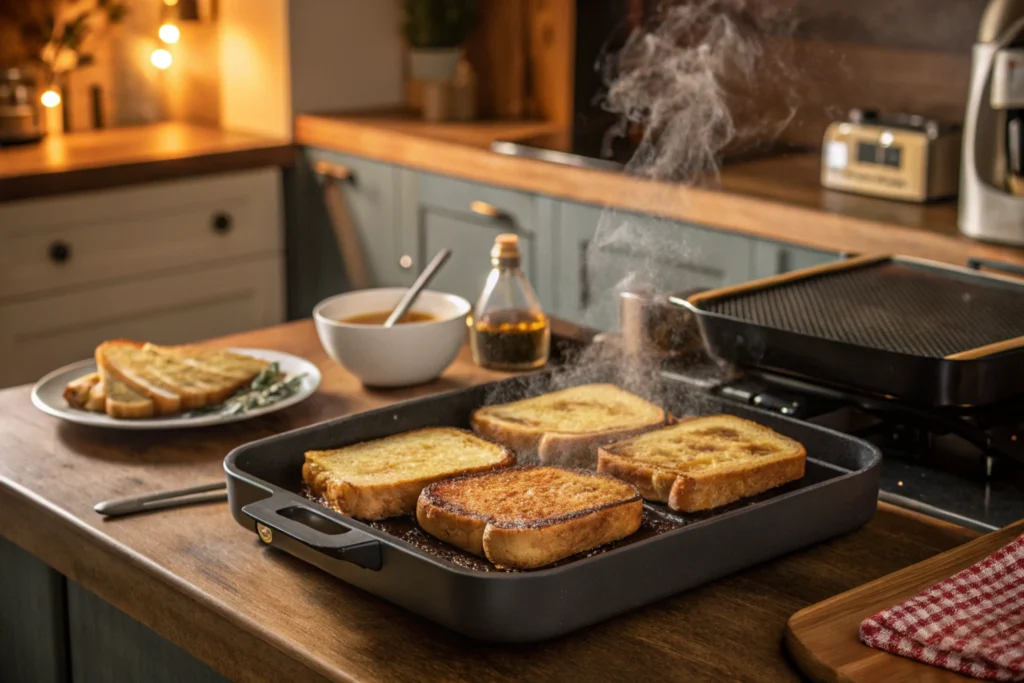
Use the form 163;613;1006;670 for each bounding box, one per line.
0;168;285;387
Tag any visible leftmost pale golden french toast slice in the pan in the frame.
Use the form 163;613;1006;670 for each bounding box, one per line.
302;427;515;519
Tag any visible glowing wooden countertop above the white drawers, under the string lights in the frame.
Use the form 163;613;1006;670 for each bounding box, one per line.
0;122;293;202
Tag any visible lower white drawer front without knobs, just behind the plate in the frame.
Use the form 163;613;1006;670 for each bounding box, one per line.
0;256;284;387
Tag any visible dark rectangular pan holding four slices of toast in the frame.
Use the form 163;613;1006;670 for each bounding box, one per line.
224;373;881;642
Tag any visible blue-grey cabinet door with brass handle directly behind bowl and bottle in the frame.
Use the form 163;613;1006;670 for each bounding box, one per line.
401;171;551;305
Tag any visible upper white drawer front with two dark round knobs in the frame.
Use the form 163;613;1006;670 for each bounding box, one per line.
0;169;284;301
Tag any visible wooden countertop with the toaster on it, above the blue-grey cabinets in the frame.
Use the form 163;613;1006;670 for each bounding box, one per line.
295;115;1024;265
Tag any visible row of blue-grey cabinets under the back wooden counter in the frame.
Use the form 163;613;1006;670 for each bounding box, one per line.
289;150;839;329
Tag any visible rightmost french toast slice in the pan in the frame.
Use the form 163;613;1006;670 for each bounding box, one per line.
597;415;807;512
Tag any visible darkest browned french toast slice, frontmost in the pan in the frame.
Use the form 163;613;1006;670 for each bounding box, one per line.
416;466;643;569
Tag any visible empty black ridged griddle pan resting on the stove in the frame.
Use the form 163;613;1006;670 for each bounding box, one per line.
673;256;1024;407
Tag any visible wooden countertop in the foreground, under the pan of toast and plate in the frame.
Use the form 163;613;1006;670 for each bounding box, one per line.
0;321;976;682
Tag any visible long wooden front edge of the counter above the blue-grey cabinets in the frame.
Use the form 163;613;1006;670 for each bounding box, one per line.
295;115;1024;265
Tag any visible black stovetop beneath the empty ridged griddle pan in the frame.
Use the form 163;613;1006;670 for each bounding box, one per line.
666;358;1024;531
